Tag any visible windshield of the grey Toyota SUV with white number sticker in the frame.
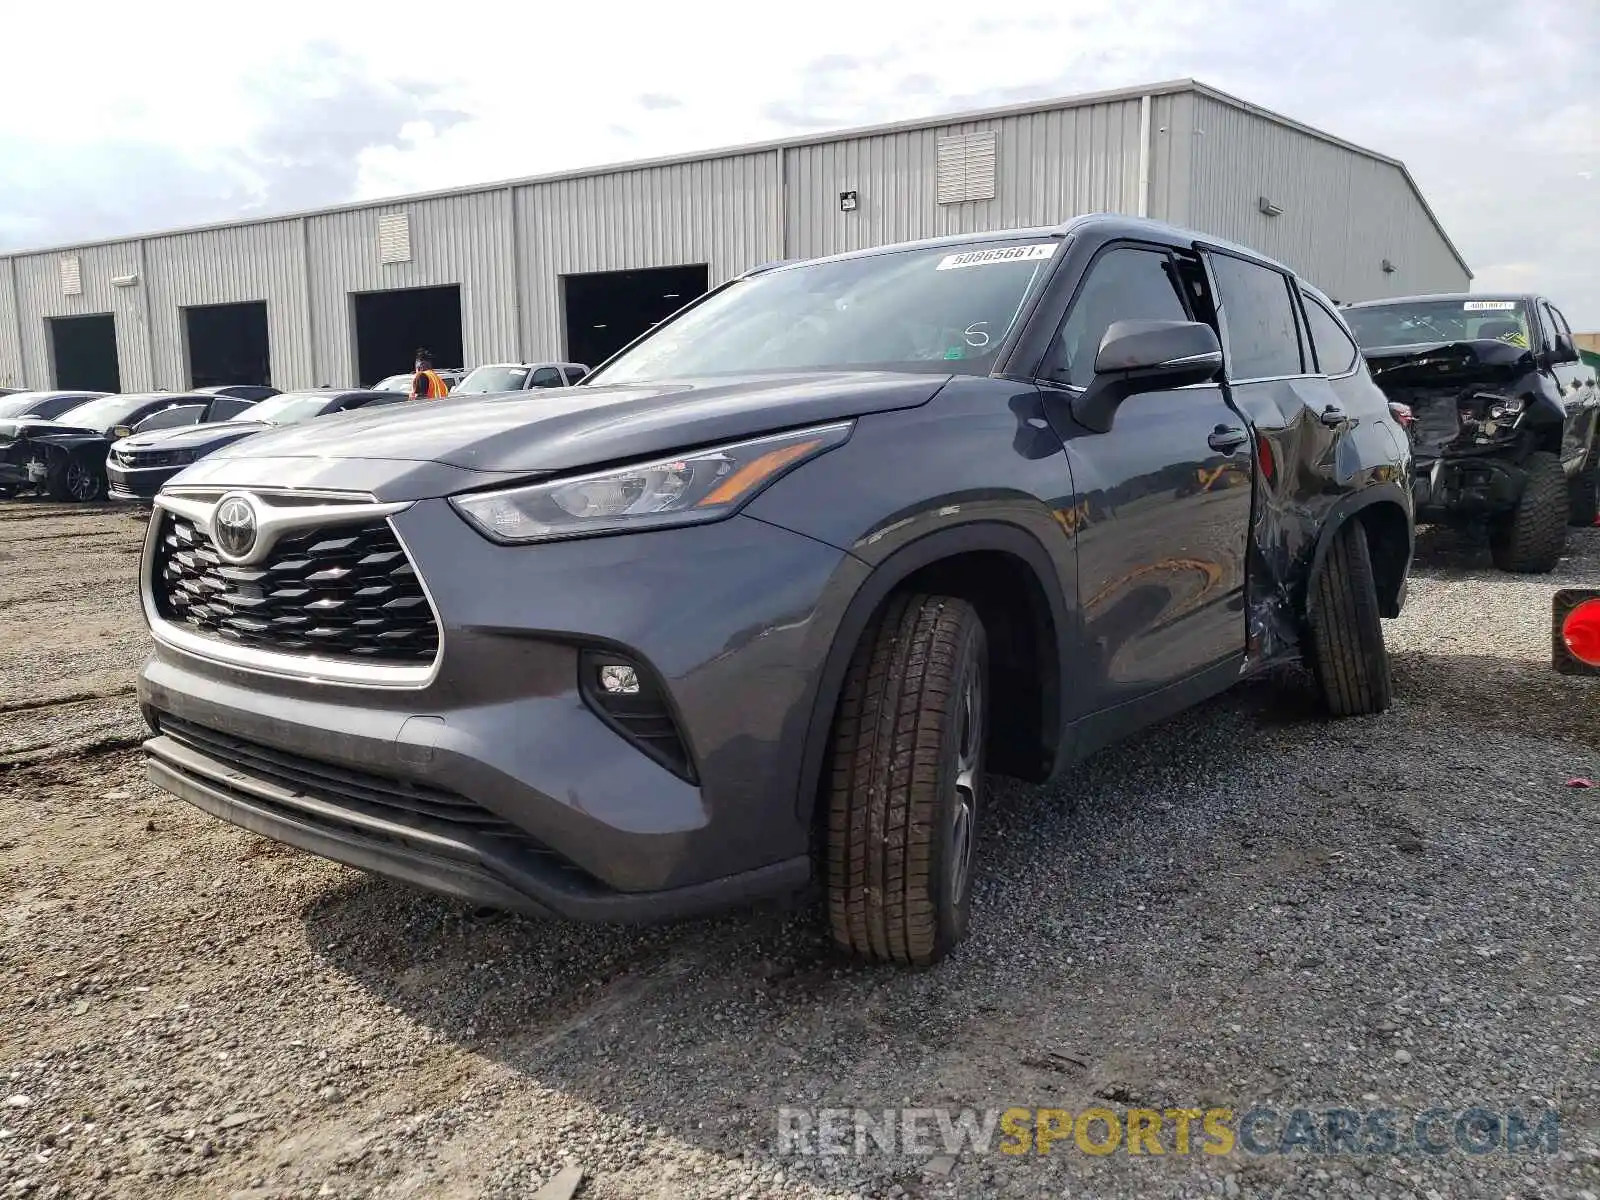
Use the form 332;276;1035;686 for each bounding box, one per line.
586;240;1061;384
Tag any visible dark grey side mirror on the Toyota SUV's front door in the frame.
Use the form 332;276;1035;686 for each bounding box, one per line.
1072;320;1222;434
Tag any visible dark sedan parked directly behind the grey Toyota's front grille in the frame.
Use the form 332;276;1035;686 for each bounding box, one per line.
106;389;406;504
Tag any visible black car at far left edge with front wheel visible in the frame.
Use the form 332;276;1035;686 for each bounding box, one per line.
0;392;211;501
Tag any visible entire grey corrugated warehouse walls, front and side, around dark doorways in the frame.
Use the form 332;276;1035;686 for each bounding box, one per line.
0;90;1467;390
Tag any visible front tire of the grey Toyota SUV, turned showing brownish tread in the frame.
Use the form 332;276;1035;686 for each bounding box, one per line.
824;594;989;966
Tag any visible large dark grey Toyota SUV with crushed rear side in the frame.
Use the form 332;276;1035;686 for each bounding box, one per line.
139;216;1411;963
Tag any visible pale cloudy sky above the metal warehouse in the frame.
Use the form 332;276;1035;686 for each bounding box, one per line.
0;0;1600;330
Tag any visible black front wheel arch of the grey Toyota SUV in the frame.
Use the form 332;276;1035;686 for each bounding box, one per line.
797;522;1072;826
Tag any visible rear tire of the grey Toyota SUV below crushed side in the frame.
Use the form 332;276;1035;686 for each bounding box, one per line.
1306;520;1394;717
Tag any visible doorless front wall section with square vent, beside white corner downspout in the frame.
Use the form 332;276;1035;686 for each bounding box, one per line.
786;99;1139;258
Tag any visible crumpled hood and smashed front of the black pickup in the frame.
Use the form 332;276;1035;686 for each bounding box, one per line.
1362;341;1538;459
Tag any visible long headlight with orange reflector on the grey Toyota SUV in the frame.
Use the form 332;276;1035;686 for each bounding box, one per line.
450;421;853;542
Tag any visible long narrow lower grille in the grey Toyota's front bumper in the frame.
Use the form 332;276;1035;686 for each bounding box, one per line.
157;712;521;850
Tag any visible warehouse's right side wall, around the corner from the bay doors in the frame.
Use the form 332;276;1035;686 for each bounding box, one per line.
1187;94;1470;301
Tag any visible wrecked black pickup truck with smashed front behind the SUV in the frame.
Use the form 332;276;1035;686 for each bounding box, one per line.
1344;294;1600;574
